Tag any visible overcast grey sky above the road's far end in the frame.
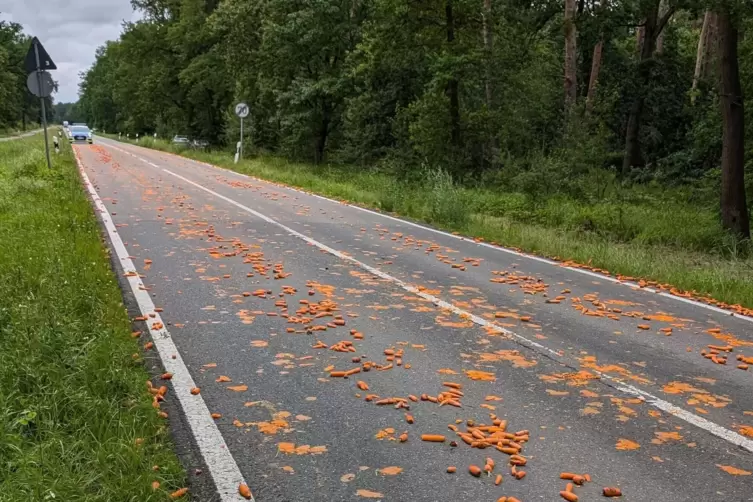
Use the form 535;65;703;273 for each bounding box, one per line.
0;0;138;102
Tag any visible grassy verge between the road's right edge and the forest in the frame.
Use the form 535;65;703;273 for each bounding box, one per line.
104;138;753;308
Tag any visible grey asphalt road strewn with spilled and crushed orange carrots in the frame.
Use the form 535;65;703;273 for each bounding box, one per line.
74;139;753;502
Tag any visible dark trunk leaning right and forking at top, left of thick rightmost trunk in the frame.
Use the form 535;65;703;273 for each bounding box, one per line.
622;0;675;174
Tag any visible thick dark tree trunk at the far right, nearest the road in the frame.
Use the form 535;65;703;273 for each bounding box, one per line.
717;5;750;238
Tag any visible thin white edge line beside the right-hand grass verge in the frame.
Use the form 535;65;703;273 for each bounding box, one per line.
100;137;753;323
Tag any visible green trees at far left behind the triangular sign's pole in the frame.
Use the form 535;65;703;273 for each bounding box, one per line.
0;20;50;130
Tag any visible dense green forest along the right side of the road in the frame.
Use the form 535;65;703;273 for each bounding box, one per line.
78;0;753;236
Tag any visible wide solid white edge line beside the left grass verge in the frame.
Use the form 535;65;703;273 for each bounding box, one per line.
74;147;253;502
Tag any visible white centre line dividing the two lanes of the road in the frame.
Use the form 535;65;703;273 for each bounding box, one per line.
103;137;753;453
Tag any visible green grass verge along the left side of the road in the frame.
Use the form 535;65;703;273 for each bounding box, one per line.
0;135;185;502
